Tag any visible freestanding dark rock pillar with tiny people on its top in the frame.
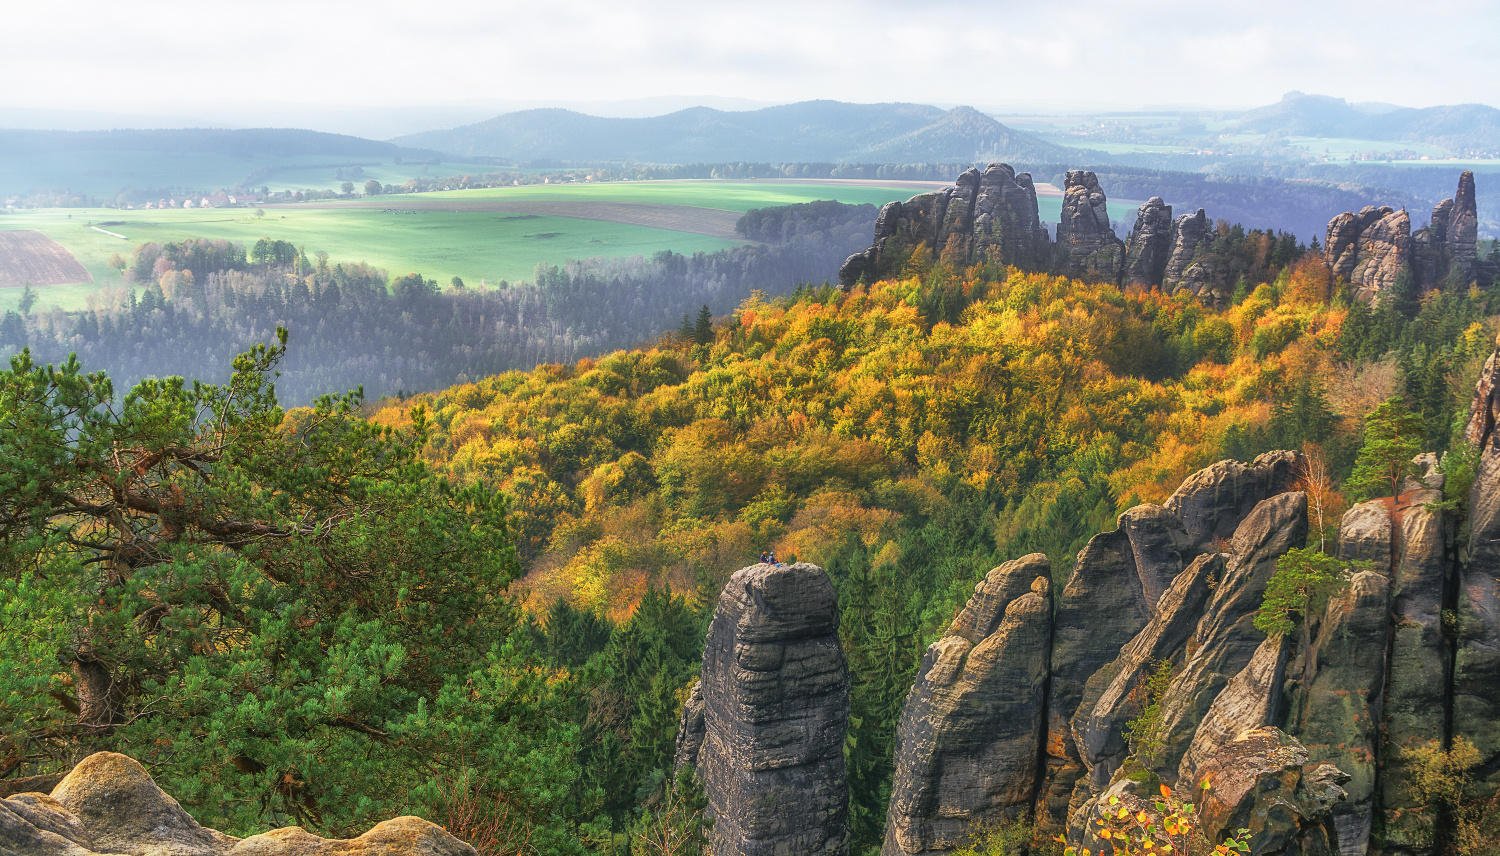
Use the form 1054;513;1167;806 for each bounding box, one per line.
698;562;849;856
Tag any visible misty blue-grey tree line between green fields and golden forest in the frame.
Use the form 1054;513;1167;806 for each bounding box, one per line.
0;205;873;405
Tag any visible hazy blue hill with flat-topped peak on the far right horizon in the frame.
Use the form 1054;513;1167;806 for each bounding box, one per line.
1239;91;1500;153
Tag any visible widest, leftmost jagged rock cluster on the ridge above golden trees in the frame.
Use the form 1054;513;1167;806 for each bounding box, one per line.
839;163;1052;288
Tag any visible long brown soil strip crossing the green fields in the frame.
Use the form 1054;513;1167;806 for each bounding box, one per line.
285;200;744;241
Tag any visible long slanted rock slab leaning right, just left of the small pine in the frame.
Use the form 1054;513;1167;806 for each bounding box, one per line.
1157;492;1308;771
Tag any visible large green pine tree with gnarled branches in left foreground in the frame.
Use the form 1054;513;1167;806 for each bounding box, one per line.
0;330;597;853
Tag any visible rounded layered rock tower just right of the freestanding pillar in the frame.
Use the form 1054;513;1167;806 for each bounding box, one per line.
882;553;1052;856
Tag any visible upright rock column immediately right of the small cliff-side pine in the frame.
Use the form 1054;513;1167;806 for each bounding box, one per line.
1287;571;1391;856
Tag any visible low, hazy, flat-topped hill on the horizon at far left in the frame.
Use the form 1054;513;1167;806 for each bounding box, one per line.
0;127;435;157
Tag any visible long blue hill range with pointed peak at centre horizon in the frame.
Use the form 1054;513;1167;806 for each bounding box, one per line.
392;100;1079;163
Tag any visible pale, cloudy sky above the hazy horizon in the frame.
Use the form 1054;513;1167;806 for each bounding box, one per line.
0;0;1500;135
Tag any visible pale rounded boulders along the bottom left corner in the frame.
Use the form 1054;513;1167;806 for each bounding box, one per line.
0;753;477;856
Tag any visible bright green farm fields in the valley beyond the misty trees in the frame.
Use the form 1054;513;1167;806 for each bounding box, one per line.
0;179;936;312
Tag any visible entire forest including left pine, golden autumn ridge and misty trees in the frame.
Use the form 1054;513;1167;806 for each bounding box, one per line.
0;210;1500;856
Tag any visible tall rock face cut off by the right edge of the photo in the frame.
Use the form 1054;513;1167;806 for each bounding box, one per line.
1452;343;1500;799
